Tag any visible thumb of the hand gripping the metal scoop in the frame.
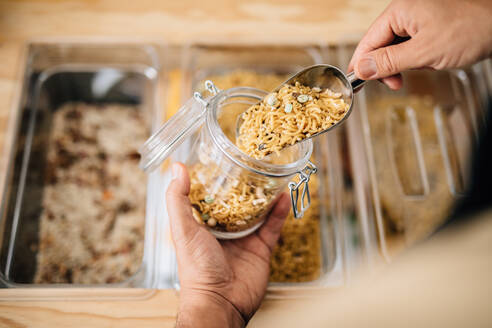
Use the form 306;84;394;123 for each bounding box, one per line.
355;39;424;80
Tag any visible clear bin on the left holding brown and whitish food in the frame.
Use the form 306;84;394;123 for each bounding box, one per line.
0;42;171;298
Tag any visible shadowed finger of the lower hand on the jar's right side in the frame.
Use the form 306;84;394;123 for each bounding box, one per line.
258;193;290;251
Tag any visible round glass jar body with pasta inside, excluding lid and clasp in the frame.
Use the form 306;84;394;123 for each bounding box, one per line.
190;88;312;239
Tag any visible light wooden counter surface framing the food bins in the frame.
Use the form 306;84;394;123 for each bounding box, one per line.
0;0;389;327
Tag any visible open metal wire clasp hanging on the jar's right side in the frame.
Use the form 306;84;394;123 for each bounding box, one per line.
289;161;318;219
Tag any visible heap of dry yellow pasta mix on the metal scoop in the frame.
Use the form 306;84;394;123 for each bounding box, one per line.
236;82;349;159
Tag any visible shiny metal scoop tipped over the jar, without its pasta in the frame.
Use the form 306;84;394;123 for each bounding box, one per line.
236;64;366;141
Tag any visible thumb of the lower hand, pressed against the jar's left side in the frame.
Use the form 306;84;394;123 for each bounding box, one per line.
166;163;200;248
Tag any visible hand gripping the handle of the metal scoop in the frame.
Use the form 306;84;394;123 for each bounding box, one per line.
348;0;492;90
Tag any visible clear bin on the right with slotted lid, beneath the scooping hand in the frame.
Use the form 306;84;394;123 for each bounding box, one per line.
327;45;490;261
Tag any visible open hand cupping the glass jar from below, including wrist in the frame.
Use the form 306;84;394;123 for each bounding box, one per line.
166;163;290;327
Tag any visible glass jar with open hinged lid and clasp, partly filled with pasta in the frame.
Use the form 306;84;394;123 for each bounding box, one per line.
140;81;316;239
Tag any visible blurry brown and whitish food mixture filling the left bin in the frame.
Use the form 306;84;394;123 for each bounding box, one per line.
35;103;149;284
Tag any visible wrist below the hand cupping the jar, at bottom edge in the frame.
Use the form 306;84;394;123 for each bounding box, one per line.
176;290;246;328
